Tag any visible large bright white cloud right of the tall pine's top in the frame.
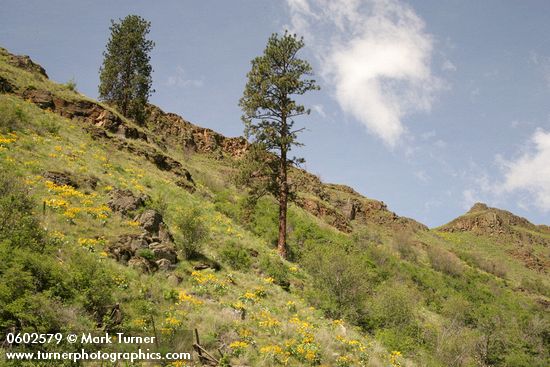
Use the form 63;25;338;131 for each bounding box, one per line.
287;0;442;147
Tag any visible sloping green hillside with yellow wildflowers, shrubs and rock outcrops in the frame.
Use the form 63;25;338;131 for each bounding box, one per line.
0;50;550;367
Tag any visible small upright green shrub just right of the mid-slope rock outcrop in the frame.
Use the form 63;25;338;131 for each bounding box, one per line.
175;206;208;259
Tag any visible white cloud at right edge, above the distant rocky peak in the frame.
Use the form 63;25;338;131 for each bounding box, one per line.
498;129;550;211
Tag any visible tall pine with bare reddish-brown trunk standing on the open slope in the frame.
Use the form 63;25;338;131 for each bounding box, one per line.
239;32;319;257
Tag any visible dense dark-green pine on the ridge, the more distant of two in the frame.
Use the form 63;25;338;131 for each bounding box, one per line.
99;15;155;123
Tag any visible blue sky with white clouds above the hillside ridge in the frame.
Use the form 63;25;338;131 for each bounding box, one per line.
0;0;550;226
